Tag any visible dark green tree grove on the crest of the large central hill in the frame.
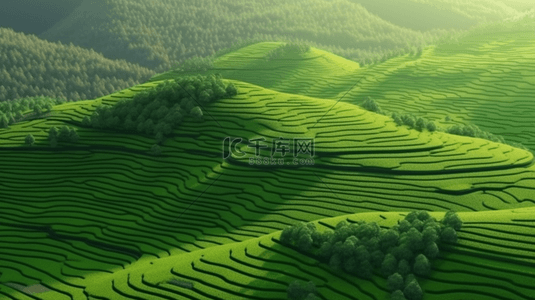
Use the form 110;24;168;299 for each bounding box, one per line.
82;74;238;143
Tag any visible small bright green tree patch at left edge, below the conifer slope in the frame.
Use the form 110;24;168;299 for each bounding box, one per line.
0;97;65;128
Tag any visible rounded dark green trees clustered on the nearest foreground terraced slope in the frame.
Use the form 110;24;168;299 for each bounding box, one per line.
280;211;462;300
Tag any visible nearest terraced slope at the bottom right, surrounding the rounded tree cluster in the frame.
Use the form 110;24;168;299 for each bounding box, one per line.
86;208;535;300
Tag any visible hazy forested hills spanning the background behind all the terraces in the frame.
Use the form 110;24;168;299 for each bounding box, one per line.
0;0;533;101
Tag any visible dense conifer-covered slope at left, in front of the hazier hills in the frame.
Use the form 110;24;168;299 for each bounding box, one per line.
0;28;155;102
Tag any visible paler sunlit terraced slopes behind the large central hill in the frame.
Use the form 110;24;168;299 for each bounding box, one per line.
153;16;535;150
